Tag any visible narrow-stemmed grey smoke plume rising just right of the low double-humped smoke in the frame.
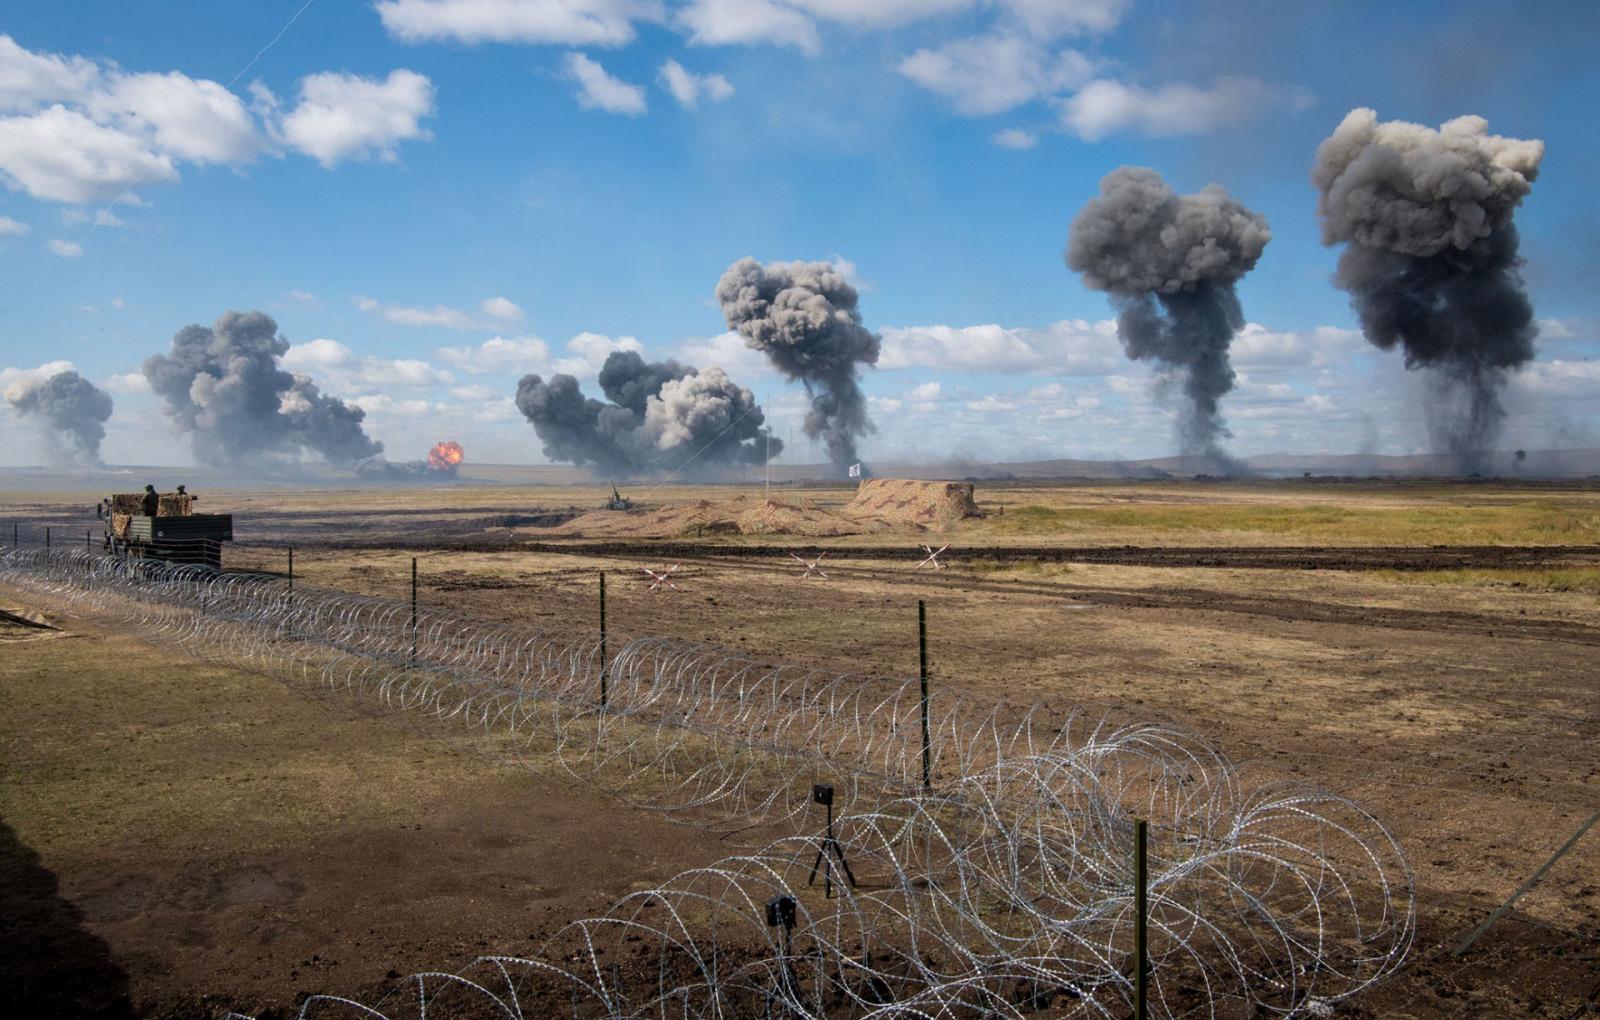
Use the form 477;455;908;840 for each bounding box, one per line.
717;259;883;467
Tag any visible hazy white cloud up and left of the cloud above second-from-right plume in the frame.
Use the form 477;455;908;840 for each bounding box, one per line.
899;34;1094;117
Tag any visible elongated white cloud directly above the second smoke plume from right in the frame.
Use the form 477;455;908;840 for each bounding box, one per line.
1059;78;1309;142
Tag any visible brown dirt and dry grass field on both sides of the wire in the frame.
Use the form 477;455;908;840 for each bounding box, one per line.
0;484;1600;1018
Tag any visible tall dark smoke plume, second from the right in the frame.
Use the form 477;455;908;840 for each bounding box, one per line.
1066;166;1272;465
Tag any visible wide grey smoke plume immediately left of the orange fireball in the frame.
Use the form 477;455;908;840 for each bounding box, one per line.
144;312;384;467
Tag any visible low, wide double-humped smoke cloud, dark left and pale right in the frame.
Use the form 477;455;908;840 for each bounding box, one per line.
517;350;782;476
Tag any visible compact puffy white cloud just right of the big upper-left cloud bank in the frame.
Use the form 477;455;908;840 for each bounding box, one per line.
268;69;434;168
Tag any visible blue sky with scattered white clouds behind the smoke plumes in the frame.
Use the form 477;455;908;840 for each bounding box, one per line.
0;0;1600;464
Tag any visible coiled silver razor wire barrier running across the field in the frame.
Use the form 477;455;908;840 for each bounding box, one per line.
0;548;1416;1020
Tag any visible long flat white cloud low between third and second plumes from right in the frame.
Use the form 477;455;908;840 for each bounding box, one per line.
878;320;1123;376
